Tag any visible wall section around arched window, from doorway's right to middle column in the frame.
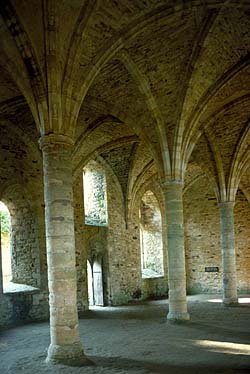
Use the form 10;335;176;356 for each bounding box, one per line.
104;164;168;305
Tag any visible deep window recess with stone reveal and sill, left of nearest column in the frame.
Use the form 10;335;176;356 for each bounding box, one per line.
0;194;40;294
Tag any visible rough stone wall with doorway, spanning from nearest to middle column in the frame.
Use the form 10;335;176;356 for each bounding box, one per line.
74;160;167;311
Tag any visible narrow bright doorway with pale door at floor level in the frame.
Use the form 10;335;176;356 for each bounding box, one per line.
87;259;104;306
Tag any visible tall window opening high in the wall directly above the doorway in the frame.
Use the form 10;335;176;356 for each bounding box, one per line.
83;161;108;226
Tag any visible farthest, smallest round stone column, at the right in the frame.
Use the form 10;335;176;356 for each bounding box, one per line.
219;201;238;305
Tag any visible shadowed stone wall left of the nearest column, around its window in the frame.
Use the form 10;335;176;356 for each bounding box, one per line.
0;123;49;326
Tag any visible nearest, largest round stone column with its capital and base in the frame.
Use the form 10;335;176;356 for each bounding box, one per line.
39;134;87;366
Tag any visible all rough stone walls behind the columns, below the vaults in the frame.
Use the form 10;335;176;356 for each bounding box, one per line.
0;119;250;325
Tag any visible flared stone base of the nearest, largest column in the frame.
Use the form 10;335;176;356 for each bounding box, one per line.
46;343;94;366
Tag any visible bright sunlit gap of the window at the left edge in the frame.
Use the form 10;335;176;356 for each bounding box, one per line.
0;201;12;285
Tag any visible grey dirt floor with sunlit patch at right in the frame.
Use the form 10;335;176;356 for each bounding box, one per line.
0;296;250;374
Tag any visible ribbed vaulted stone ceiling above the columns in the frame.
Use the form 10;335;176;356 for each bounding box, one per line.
0;0;250;200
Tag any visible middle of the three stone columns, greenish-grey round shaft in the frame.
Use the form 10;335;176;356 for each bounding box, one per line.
164;180;190;322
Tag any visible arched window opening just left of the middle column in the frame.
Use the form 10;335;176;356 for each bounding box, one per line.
139;191;164;278
